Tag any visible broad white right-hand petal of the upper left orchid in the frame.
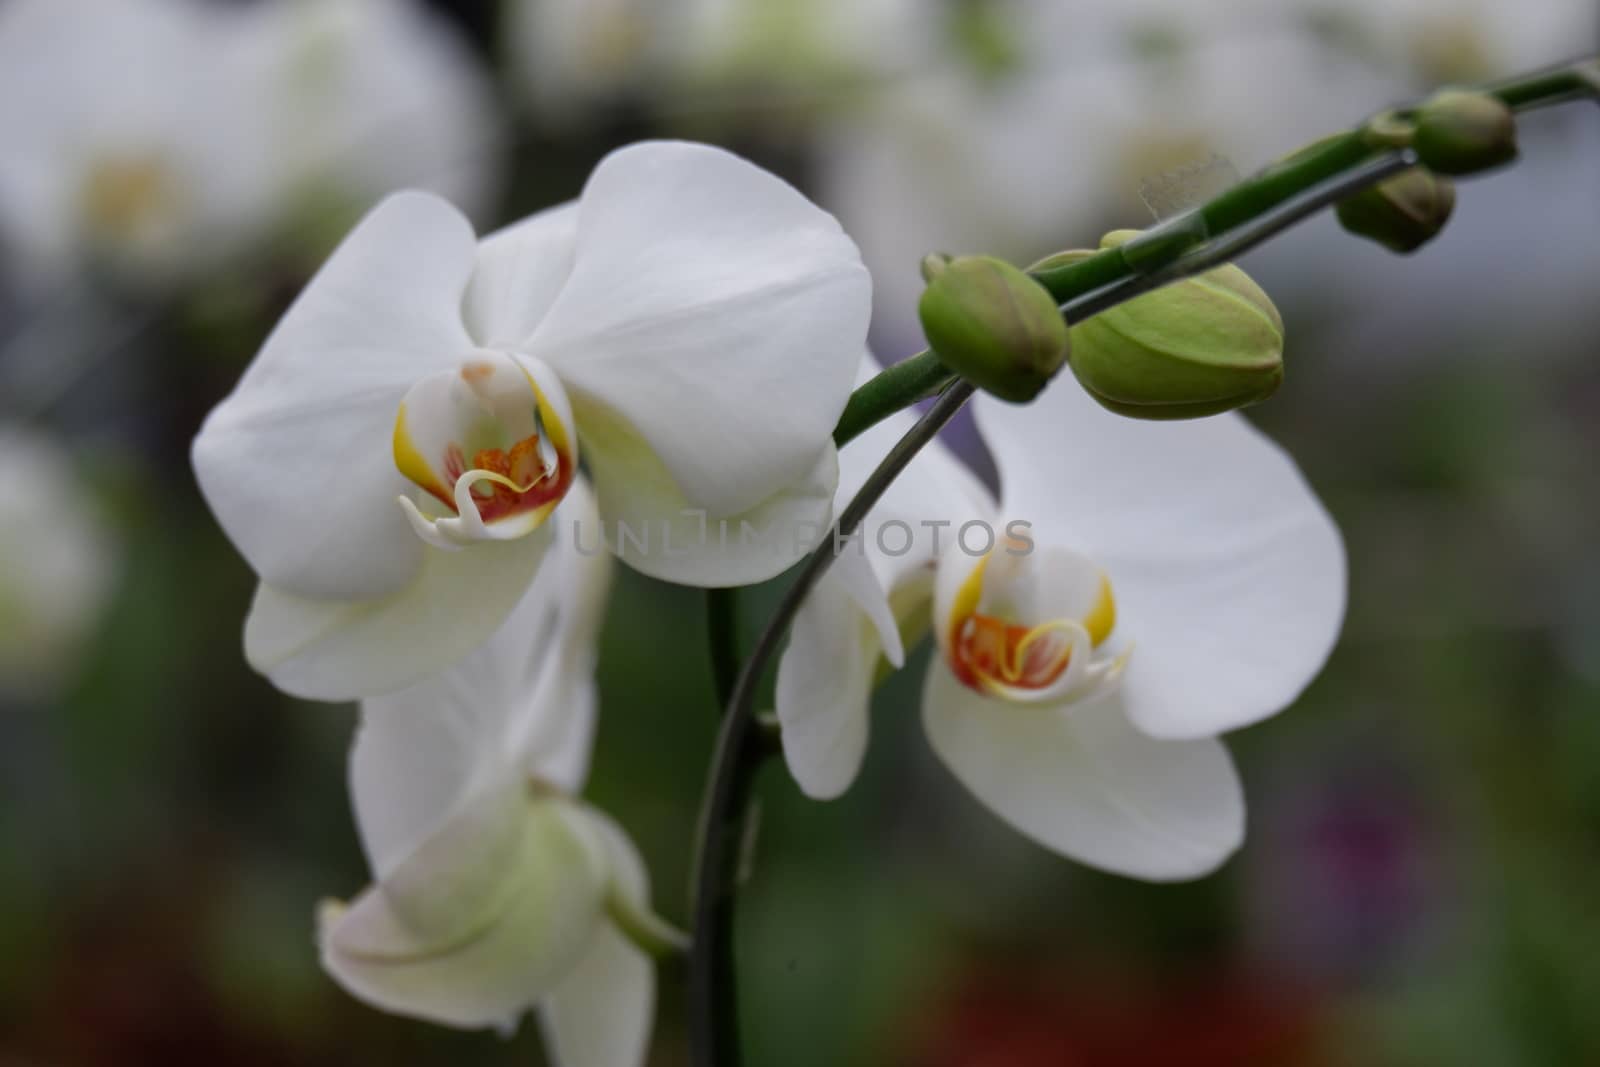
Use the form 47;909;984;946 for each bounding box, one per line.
525;142;870;524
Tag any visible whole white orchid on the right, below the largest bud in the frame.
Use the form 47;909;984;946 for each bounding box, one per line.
778;371;1344;880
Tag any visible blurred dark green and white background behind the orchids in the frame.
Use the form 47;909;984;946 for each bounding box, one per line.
0;0;1600;1067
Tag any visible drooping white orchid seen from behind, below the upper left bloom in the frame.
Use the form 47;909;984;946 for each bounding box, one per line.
318;482;677;1067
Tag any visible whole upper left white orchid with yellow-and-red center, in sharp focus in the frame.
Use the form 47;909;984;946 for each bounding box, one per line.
194;142;870;710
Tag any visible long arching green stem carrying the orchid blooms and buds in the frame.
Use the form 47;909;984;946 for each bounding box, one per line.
700;61;1600;1067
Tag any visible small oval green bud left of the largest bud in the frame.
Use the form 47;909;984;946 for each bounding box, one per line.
917;256;1067;403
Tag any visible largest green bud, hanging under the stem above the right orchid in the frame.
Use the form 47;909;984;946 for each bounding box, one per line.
1043;230;1283;419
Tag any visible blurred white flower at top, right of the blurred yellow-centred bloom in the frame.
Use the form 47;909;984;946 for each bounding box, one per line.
227;0;506;218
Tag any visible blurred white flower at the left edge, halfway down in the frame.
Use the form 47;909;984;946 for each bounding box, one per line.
0;424;117;696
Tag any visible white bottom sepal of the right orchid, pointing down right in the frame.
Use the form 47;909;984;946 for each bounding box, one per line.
922;662;1245;881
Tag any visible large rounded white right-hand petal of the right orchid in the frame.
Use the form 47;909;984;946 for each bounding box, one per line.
978;381;1346;737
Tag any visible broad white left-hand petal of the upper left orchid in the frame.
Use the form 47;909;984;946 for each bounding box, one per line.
194;194;475;600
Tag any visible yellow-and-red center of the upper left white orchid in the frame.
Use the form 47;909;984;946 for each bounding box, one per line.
394;354;578;547
